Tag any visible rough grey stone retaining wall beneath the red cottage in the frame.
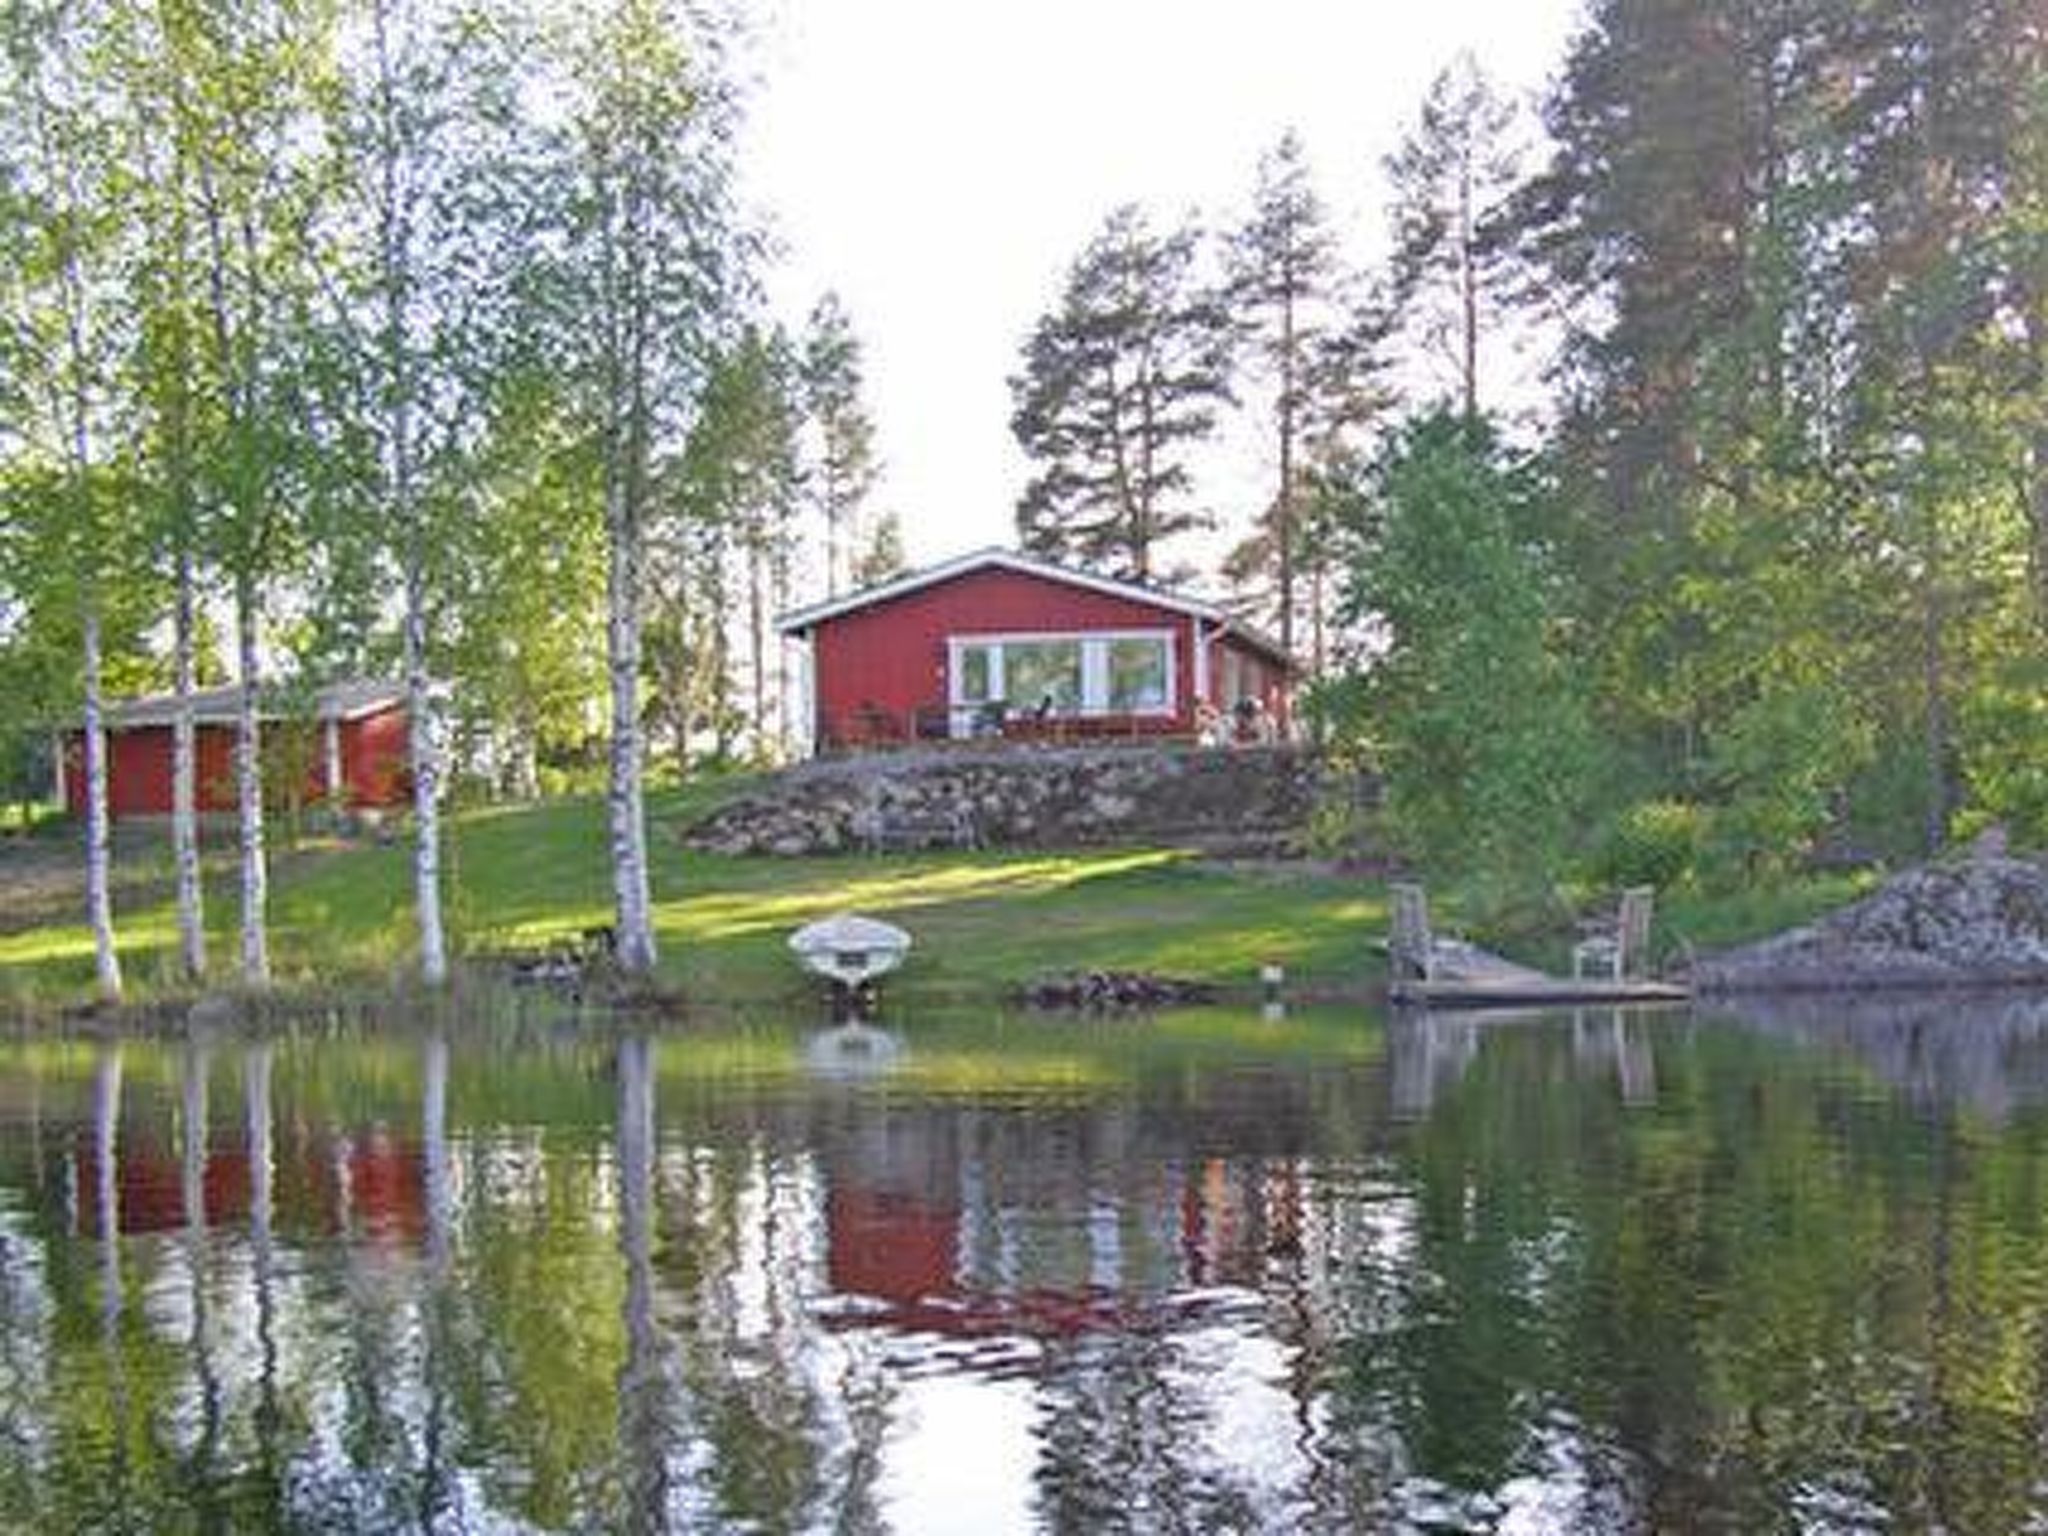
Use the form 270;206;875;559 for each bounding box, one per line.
682;745;1321;854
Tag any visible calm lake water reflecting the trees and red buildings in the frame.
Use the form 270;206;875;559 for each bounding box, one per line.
0;999;2048;1532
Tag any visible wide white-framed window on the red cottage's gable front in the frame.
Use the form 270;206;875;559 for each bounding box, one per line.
950;631;1174;717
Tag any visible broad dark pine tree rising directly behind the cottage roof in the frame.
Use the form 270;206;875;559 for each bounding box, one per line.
1010;207;1229;580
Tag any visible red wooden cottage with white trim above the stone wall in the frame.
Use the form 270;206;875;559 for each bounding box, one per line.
780;549;1292;750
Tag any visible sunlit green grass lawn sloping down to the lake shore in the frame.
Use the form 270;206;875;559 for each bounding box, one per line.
0;784;1862;1014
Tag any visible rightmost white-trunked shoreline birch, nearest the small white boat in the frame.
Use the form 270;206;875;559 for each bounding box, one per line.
555;0;729;975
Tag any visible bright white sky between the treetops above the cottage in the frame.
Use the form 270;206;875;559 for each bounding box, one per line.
741;0;1579;561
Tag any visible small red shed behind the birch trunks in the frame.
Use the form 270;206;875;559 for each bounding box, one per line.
63;682;412;817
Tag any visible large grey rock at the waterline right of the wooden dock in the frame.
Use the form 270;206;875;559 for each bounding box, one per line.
1692;856;2048;991
